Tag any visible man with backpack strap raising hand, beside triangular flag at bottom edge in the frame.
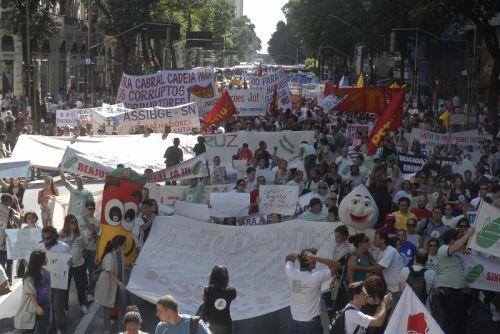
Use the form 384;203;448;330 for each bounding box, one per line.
344;281;392;334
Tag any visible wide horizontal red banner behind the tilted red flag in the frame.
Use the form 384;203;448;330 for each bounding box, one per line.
334;87;398;114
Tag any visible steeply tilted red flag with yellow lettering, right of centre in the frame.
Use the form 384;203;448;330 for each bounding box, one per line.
366;89;404;155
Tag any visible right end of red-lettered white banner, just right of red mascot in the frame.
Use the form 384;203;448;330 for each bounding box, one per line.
148;154;208;182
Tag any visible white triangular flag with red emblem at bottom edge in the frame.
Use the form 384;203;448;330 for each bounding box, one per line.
384;285;444;334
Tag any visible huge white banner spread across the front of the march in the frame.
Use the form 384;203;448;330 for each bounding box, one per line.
127;216;340;320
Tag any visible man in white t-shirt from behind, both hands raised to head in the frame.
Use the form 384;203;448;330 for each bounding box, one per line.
285;249;340;334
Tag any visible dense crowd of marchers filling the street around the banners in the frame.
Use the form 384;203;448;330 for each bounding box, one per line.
0;79;500;334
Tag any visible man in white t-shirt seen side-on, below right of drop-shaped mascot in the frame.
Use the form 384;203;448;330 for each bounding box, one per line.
373;231;404;296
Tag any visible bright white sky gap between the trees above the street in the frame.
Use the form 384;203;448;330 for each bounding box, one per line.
243;0;288;53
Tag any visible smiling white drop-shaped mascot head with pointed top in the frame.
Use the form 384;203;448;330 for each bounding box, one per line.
339;184;378;230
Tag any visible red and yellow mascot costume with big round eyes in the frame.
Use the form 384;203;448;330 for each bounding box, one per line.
98;168;145;265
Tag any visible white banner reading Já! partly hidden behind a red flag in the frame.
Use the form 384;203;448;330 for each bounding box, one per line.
191;89;267;117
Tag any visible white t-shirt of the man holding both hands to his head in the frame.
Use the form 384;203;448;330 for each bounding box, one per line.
285;261;332;321
